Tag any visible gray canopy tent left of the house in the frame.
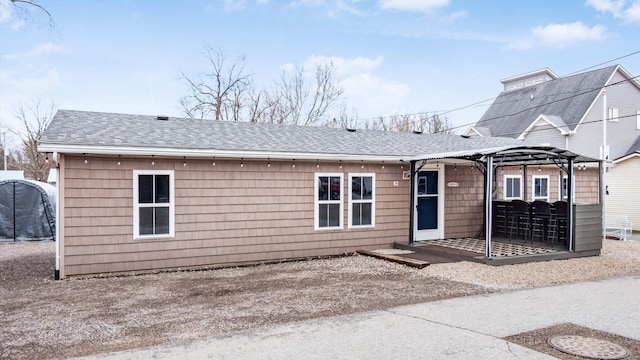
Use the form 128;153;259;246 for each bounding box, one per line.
0;180;56;241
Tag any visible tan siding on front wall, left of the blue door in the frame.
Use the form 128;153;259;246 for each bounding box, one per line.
63;157;409;276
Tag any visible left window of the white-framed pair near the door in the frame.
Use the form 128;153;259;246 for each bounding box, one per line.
314;173;344;230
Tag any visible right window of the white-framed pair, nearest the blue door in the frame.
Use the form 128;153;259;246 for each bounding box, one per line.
348;173;376;228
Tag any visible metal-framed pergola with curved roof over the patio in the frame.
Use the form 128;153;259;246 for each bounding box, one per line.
409;145;605;260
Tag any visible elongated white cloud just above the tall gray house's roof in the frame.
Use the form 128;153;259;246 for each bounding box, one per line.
508;21;607;49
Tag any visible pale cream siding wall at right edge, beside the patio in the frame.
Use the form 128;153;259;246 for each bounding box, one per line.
605;156;640;231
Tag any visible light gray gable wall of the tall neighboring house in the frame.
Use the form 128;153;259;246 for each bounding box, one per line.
568;72;640;160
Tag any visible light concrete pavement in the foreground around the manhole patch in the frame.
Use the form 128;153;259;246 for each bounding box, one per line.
77;276;640;360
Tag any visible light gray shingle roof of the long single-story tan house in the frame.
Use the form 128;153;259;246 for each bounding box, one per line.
40;110;523;157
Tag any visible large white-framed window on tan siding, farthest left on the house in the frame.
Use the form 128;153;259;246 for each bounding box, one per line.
133;170;175;239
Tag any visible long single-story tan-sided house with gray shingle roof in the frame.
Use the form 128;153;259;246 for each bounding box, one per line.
39;110;599;278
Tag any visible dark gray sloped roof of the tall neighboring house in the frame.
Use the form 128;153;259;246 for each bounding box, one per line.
475;65;618;138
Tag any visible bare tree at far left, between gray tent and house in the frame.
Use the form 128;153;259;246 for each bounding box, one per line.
12;101;55;181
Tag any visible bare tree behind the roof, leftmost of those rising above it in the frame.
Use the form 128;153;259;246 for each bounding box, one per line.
180;48;251;121
